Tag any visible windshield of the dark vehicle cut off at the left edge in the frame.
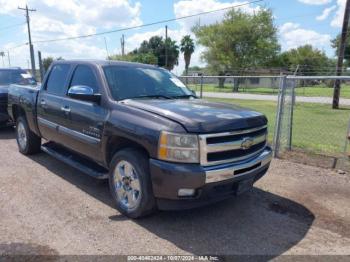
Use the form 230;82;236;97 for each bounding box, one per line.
0;70;36;85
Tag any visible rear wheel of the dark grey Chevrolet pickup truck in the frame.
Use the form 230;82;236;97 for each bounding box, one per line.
16;116;41;155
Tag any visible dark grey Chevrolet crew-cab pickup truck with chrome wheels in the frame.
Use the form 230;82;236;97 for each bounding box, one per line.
8;60;272;218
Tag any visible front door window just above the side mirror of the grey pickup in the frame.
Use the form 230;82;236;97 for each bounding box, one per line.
70;65;98;93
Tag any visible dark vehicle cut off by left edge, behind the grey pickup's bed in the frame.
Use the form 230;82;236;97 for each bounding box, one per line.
0;67;36;127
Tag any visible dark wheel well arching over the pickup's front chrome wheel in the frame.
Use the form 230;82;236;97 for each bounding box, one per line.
107;136;149;165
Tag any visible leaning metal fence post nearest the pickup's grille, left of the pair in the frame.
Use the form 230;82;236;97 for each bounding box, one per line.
273;76;287;157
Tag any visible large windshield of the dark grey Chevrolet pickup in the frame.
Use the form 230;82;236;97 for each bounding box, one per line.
103;65;194;100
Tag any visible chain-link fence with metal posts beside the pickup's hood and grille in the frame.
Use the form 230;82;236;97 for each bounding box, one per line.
180;75;350;169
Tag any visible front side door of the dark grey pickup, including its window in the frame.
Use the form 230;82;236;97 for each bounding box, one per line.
62;64;108;162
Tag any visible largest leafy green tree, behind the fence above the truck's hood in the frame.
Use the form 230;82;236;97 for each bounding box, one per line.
193;9;280;91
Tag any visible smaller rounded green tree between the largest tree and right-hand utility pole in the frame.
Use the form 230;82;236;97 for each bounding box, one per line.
280;45;334;76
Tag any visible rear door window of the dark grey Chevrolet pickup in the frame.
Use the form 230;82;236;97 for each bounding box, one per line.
46;64;70;95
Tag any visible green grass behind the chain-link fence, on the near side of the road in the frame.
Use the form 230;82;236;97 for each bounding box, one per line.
208;98;350;155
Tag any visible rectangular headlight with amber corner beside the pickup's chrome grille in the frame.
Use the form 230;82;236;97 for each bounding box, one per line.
158;131;199;163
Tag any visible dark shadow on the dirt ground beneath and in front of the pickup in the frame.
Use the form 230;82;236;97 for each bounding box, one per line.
31;153;315;256
